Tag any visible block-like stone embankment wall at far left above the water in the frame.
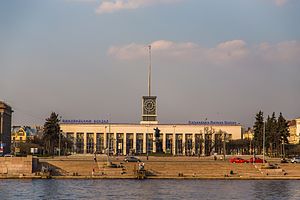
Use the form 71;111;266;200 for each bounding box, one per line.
0;156;37;175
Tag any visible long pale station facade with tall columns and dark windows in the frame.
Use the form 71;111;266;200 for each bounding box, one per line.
60;120;242;156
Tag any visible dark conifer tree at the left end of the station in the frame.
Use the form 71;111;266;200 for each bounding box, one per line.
43;112;60;155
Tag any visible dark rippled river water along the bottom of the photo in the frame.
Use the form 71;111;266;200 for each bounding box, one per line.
0;179;300;200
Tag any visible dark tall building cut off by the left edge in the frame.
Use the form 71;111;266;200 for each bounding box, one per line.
0;101;13;154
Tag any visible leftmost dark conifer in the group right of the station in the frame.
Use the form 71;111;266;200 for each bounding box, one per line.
253;111;264;154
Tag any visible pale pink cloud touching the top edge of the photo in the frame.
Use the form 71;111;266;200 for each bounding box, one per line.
96;0;183;14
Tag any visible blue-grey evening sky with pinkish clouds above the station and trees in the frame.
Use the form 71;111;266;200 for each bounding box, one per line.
0;0;300;127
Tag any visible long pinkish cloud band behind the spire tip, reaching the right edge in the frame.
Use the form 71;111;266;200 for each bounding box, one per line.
108;40;300;65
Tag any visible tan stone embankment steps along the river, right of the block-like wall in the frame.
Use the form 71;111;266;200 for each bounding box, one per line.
35;155;300;179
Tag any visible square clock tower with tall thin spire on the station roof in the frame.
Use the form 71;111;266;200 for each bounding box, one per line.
141;45;158;124
